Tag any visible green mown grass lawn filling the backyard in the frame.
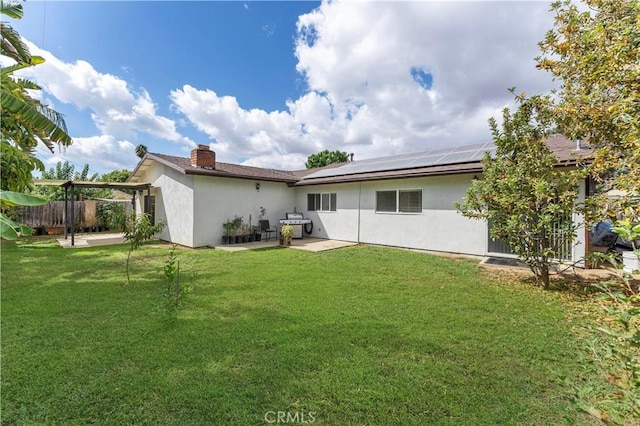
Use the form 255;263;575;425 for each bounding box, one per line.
1;240;584;425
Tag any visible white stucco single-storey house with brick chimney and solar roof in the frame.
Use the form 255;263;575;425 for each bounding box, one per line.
129;135;587;260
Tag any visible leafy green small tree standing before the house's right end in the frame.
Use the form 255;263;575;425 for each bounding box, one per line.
456;90;580;288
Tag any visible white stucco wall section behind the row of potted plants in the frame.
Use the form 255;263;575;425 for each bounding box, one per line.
191;176;295;247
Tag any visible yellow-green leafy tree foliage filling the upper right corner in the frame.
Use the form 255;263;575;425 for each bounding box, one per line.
536;0;640;213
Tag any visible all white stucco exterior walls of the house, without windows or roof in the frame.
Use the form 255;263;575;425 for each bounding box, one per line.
137;163;586;259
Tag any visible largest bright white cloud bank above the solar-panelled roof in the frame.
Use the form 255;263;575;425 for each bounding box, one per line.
171;1;553;168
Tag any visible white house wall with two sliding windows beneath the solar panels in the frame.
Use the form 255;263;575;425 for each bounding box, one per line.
296;175;487;255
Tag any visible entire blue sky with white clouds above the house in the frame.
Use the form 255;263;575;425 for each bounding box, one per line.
11;0;553;173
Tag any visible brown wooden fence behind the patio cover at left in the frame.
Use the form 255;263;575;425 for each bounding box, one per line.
18;200;133;233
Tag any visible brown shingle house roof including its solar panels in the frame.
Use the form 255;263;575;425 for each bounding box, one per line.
129;135;592;186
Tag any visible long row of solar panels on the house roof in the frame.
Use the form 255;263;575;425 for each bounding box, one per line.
305;142;495;179
